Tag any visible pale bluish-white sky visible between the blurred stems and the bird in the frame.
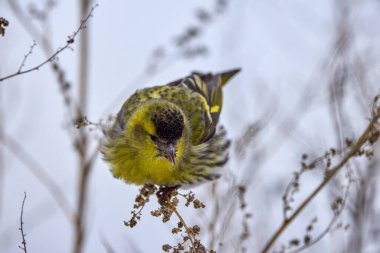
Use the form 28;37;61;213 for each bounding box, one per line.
0;0;380;253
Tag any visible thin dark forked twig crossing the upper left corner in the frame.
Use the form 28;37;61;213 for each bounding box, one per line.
0;5;97;82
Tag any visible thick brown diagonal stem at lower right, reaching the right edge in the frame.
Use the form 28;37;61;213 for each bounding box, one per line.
261;97;380;253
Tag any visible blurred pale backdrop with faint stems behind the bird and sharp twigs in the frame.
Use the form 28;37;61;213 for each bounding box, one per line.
0;0;380;253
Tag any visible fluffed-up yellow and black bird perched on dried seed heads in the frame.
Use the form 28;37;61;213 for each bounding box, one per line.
101;68;240;204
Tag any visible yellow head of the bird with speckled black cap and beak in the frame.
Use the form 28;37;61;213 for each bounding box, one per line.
127;100;188;168
